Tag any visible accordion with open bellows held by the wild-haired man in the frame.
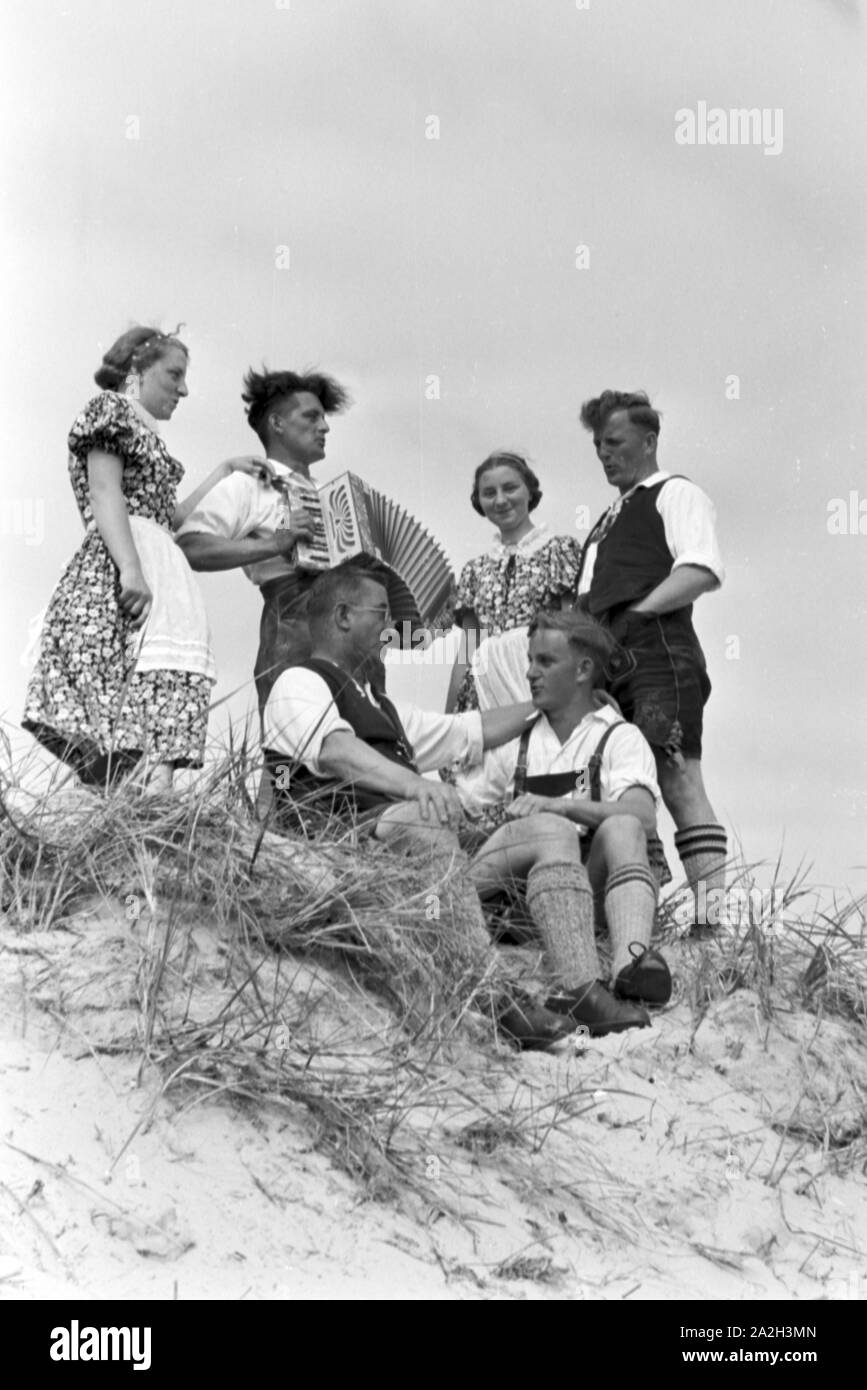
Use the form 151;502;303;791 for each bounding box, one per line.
281;473;454;646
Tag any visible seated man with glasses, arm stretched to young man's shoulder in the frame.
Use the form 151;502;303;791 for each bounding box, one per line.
263;564;589;1048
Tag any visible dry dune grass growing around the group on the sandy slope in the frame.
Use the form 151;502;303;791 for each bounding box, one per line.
0;738;867;1223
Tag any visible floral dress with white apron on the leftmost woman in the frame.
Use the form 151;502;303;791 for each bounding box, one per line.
22;391;215;784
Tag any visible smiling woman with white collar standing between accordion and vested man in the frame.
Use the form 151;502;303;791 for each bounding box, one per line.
446;450;581;712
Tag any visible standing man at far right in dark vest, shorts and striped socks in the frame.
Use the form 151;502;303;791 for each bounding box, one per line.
578;391;727;931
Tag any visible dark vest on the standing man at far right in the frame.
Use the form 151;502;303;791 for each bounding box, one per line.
584;474;692;617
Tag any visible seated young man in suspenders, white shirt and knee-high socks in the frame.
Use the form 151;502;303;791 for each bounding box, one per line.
456;612;671;1036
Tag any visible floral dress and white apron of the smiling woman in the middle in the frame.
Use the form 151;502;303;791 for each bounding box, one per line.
454;524;581;710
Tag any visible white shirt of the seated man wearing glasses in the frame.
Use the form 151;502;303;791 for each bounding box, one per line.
263;666;482;777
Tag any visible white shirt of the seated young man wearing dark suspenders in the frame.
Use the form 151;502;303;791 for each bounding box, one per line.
456;705;660;834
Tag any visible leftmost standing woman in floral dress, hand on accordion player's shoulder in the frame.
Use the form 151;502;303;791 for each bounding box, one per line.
22;318;264;791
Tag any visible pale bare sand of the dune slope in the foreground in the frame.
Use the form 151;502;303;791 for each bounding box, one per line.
0;909;867;1300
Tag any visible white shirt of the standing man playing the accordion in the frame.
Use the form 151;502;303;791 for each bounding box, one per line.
175;459;317;584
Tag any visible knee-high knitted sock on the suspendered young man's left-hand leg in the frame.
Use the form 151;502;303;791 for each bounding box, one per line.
527;860;599;990
